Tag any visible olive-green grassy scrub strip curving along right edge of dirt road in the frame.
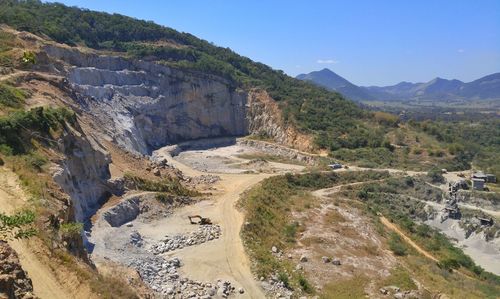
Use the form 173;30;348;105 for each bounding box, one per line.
241;171;389;292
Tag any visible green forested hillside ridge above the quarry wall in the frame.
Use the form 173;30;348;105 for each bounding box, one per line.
0;0;386;154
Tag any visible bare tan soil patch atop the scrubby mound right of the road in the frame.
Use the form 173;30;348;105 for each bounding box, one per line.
302;181;396;298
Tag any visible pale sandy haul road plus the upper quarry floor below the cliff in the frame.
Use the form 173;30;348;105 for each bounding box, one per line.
152;146;303;298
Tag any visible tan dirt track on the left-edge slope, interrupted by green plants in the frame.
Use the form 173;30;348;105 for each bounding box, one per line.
0;167;92;299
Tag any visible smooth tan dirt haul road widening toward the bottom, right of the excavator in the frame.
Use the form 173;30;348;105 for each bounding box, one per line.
168;157;275;298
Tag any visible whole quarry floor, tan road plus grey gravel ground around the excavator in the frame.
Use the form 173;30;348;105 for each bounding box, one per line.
90;145;304;298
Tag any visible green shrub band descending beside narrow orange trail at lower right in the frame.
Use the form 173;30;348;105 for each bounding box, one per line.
346;177;500;294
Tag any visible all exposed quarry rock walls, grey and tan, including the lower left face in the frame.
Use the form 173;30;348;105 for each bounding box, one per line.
42;45;312;222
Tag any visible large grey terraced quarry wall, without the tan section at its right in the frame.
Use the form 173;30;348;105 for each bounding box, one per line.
45;47;248;154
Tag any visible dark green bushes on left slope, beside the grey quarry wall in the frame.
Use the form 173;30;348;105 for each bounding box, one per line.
0;107;74;155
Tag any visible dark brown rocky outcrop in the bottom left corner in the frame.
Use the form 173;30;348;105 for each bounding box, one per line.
0;241;36;299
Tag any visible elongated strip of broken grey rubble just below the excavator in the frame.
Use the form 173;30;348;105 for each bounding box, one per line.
150;224;222;254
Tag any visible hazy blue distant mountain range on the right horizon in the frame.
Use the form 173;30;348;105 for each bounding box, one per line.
297;68;500;101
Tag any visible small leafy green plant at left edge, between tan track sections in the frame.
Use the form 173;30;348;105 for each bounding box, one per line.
0;211;36;241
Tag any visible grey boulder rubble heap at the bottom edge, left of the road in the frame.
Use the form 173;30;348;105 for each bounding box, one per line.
129;257;241;299
